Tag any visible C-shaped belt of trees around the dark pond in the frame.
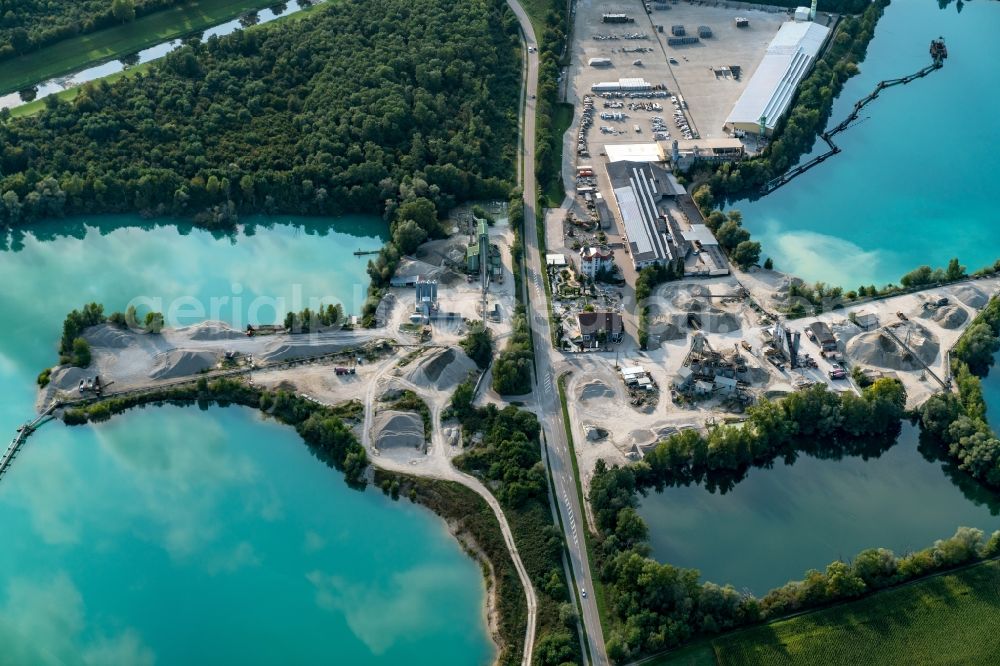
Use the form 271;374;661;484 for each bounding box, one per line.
589;379;952;662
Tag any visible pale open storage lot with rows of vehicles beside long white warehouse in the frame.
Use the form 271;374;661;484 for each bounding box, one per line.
566;0;789;148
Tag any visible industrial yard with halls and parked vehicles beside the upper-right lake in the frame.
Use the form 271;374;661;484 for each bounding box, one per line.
546;2;848;330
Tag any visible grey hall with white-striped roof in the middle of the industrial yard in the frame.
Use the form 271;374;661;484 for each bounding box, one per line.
608;162;684;270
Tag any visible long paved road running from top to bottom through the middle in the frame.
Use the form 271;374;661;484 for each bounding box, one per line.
508;0;609;666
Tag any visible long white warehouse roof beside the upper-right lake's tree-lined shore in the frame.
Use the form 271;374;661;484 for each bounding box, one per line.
726;21;830;130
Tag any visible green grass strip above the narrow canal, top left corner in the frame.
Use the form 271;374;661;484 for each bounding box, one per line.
0;0;275;94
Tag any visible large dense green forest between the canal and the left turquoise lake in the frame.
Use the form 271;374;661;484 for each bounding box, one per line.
0;0;520;228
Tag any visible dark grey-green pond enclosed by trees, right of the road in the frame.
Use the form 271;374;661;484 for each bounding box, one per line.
640;423;1000;595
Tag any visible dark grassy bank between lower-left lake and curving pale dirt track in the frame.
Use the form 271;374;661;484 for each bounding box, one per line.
375;470;528;666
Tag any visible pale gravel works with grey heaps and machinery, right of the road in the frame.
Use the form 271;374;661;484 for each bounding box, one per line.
567;271;1000;482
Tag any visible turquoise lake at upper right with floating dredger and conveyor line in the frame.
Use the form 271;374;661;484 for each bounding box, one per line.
733;0;1000;289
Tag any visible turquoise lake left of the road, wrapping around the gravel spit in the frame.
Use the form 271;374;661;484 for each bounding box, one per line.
0;217;494;664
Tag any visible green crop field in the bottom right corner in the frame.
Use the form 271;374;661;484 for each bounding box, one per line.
644;561;1000;666
